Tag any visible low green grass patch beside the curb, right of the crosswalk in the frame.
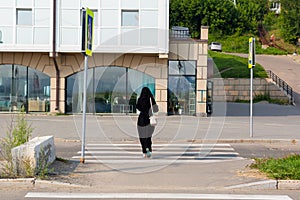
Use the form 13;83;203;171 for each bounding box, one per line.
250;155;300;180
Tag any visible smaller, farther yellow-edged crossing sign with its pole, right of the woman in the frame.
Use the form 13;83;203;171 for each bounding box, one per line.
248;37;255;137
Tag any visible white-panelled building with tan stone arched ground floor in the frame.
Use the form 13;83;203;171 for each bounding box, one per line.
0;0;208;115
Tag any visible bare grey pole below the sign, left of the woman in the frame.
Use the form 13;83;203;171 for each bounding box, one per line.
80;55;88;163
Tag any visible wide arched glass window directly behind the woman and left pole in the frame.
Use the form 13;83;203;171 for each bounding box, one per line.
66;66;155;113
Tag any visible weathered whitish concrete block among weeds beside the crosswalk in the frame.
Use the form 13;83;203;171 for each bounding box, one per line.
11;136;56;175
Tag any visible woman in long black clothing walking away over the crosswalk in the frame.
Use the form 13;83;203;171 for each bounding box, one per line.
136;87;158;158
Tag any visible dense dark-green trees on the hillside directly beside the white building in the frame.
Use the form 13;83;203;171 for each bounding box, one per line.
170;0;268;36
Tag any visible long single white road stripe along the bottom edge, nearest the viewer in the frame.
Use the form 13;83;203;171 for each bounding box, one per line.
25;192;292;200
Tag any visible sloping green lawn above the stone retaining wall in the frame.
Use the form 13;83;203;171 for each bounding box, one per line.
209;51;268;78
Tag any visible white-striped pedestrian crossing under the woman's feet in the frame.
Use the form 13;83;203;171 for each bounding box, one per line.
72;143;243;164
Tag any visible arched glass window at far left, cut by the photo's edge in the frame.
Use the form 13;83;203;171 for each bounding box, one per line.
0;64;50;112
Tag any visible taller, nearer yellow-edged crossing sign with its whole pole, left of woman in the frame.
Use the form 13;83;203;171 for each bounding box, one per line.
80;8;94;163
